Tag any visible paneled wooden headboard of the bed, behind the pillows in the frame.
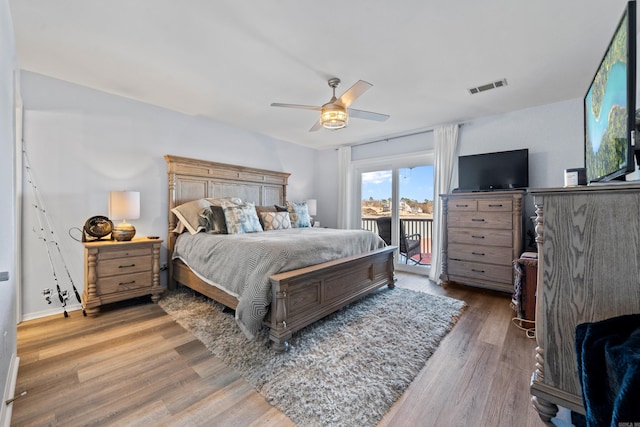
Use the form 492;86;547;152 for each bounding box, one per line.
164;154;290;253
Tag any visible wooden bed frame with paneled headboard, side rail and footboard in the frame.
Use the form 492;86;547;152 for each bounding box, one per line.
164;155;396;351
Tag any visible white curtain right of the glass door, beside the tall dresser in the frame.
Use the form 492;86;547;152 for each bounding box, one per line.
429;124;459;282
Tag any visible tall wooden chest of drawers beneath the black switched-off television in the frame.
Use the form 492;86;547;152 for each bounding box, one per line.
440;190;525;293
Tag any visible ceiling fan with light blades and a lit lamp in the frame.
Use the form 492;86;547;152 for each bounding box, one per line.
271;77;389;132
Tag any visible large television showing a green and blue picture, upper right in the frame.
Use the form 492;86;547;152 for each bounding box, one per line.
584;1;636;183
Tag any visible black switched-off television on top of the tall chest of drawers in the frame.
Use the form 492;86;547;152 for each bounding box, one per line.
458;148;529;191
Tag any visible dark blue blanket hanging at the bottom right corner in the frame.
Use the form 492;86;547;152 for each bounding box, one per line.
575;314;640;427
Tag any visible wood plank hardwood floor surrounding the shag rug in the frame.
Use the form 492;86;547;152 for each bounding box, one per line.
11;273;545;427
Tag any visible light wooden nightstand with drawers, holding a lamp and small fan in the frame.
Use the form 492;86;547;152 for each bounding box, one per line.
82;238;163;317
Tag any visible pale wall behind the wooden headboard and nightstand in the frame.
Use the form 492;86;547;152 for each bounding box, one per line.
22;72;317;319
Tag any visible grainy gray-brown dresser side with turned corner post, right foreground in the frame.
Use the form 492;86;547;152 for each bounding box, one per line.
531;185;640;421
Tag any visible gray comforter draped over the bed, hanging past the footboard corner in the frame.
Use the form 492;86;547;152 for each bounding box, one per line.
173;228;385;339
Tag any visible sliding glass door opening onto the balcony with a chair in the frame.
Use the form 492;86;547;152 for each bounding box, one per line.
356;154;434;274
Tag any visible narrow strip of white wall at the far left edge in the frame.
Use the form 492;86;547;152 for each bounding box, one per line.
0;0;17;425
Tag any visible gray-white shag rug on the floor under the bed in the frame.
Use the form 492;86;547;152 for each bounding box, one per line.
160;288;465;427
